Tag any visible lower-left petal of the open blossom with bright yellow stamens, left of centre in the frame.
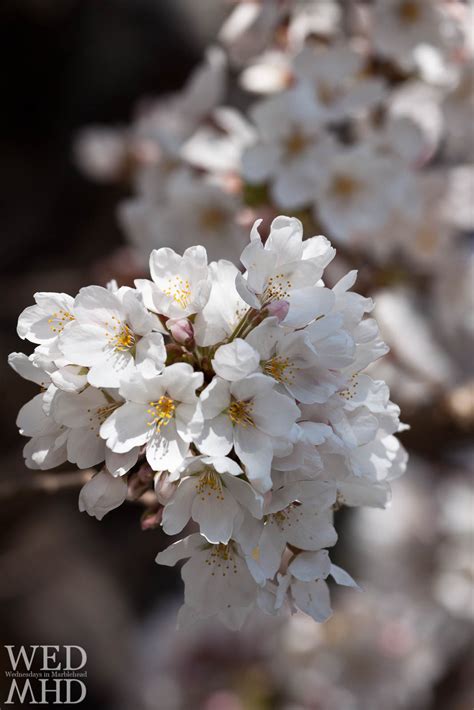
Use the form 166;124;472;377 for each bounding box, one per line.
100;402;152;454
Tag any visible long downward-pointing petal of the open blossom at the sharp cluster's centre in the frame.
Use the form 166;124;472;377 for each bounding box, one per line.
234;426;273;493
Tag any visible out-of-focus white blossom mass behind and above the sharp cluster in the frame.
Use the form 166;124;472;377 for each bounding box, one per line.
75;0;474;426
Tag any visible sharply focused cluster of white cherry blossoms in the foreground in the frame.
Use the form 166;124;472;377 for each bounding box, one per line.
10;216;406;628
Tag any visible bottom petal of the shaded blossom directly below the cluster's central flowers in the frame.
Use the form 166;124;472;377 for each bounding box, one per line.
191;489;239;544
